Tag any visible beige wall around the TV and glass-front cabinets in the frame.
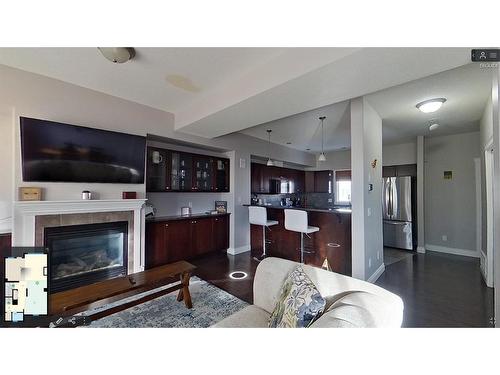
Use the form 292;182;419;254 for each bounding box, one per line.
0;65;315;253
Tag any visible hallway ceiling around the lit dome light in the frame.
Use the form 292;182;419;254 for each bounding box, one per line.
367;63;493;144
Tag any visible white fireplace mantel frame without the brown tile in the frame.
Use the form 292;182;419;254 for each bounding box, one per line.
12;199;146;272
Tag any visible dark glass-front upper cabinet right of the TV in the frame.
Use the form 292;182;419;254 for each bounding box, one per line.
146;147;229;192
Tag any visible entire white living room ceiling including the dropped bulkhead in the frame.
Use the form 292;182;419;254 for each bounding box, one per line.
0;48;470;142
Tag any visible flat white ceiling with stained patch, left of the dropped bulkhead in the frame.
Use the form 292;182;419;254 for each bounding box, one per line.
0;48;285;113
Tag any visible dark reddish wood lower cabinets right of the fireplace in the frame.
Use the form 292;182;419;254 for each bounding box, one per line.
146;214;229;269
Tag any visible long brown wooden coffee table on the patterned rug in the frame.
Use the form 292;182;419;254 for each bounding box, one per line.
49;261;196;321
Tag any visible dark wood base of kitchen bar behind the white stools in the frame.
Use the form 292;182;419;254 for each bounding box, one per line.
246;205;352;276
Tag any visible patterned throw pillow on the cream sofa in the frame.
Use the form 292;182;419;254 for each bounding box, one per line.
269;266;326;328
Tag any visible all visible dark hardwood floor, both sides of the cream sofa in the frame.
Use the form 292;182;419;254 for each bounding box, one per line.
191;252;494;327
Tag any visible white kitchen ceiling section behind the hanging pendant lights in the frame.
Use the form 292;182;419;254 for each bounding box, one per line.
241;101;351;152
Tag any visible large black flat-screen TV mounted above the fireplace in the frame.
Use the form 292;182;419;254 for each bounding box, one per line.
20;117;146;184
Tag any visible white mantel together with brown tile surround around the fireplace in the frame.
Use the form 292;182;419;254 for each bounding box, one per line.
12;199;145;274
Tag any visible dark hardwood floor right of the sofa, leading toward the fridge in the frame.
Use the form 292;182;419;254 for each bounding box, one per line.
376;251;494;327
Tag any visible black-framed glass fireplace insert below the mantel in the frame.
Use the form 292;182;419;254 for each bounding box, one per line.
44;221;128;293
